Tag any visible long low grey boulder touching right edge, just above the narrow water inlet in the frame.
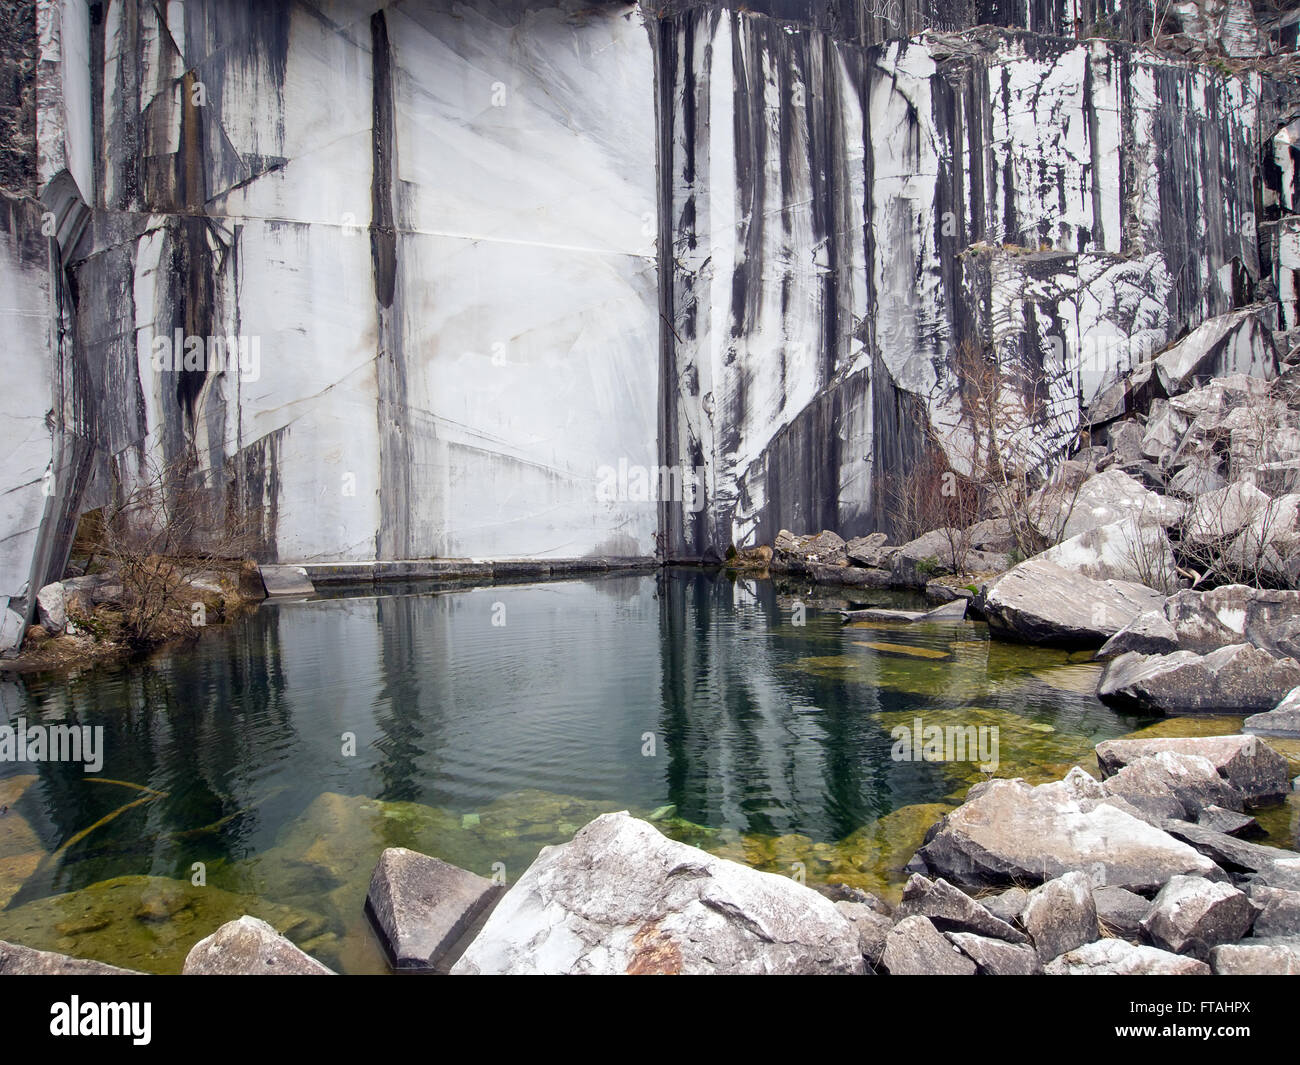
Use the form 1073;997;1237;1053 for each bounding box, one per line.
1097;644;1300;714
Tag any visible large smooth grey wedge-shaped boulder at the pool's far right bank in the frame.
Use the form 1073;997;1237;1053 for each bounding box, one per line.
980;558;1165;646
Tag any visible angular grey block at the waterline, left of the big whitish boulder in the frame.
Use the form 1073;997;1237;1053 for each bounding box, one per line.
365;847;503;970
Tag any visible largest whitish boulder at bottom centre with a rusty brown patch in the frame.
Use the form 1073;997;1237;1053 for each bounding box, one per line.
451;813;868;974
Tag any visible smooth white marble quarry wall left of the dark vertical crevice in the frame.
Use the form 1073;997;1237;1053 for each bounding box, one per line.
65;0;658;560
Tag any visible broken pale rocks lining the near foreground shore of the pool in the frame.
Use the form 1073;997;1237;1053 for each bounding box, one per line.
0;735;1300;975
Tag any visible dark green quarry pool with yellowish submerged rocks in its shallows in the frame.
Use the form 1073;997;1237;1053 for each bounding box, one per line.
0;570;1149;973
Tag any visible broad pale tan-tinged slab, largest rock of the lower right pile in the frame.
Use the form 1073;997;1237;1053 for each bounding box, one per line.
918;780;1223;891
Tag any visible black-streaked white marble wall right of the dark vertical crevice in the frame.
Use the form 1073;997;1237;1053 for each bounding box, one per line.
658;10;1260;557
